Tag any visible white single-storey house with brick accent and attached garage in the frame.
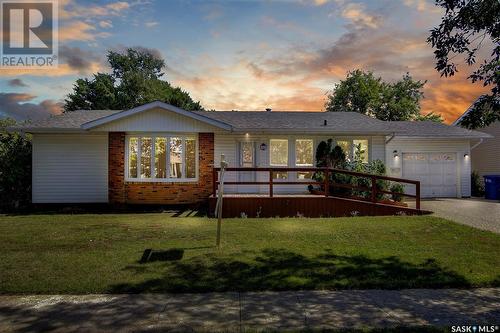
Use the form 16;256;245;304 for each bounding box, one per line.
18;102;489;204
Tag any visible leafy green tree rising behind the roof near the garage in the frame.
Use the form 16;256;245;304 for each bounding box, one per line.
325;69;432;121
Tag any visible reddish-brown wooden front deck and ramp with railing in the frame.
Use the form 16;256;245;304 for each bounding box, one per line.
209;168;430;217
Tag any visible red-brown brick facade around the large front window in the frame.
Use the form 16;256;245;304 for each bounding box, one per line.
108;132;214;204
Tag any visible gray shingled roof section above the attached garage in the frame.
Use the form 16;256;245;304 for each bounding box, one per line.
386;121;491;138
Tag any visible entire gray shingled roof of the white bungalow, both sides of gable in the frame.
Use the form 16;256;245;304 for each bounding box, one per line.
16;106;490;138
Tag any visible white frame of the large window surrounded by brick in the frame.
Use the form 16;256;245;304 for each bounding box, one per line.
124;133;200;183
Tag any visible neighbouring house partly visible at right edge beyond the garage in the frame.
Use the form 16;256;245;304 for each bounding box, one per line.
452;108;500;180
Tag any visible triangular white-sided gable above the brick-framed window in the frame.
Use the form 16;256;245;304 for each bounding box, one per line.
92;109;219;133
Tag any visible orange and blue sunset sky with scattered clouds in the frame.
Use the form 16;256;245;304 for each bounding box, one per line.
0;0;487;122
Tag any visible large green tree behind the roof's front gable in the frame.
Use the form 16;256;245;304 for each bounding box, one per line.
64;48;203;111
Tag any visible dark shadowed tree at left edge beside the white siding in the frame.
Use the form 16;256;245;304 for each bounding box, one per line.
0;118;31;211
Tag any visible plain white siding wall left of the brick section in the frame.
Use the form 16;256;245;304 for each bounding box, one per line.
32;134;108;203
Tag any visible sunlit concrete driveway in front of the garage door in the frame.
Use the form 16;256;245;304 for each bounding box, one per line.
421;198;500;234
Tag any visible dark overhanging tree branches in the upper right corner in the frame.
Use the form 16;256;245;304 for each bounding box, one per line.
427;0;500;129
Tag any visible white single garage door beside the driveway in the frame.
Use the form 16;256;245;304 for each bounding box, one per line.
403;153;457;197
